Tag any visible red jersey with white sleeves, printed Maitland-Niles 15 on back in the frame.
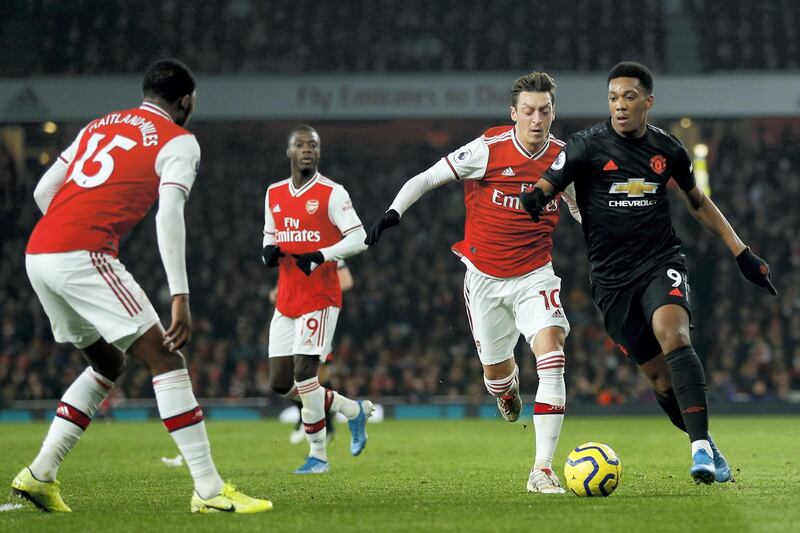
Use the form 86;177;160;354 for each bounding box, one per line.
26;103;200;256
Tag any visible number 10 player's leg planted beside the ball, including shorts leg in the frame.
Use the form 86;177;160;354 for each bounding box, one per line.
514;265;570;494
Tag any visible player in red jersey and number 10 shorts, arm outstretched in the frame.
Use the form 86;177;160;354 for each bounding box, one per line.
366;72;580;493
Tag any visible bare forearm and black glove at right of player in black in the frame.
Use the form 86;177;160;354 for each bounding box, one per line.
683;186;778;295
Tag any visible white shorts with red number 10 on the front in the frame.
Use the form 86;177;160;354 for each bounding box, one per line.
464;263;569;365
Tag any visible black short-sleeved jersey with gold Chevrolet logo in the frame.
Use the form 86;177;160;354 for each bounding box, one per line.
543;119;695;288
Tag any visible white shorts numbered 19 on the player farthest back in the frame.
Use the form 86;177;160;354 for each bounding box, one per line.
269;307;339;362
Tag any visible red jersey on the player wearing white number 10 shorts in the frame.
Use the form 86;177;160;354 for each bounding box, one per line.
445;126;564;278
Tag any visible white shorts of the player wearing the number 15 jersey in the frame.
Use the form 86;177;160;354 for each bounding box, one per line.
25;250;159;352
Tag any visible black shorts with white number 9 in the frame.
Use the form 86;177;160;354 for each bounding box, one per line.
592;256;692;365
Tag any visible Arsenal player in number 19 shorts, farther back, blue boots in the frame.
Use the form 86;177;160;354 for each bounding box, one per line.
262;126;373;474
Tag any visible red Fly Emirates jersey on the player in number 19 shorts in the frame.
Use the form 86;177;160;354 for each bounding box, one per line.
264;173;362;317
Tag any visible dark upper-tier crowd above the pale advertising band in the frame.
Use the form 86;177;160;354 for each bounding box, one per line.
6;0;800;76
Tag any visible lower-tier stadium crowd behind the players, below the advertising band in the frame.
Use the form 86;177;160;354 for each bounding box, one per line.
0;121;800;406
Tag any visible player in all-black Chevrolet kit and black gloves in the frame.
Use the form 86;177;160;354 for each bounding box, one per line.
521;62;776;483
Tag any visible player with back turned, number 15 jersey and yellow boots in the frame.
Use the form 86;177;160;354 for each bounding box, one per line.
12;60;272;513
